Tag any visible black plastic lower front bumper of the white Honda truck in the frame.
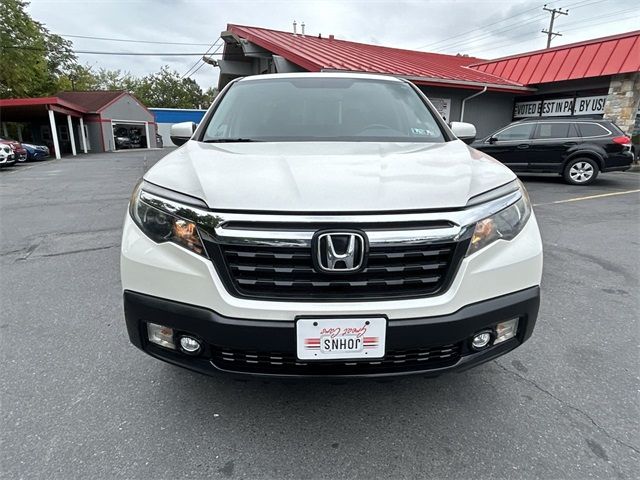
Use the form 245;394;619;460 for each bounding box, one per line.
124;286;540;378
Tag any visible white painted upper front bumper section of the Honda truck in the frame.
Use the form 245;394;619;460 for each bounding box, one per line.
121;214;542;322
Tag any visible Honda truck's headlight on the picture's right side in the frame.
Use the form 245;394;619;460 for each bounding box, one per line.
467;185;531;255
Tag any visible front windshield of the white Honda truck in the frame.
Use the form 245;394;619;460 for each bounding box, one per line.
201;77;445;142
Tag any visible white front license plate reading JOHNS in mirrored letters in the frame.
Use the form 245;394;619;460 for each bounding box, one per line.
296;317;387;360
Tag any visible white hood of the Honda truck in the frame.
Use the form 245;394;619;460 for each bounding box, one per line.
144;140;515;213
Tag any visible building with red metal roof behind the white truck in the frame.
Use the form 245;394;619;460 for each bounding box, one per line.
217;24;640;140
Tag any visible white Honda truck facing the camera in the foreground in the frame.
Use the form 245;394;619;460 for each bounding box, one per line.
121;73;542;377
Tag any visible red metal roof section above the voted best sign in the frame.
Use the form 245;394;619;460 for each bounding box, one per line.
471;30;640;85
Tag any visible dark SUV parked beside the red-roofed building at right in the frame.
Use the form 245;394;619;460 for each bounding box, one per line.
472;118;633;185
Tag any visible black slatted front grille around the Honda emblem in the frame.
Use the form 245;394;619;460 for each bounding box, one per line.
203;232;466;301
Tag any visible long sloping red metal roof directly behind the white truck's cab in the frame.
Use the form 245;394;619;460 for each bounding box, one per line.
227;24;527;91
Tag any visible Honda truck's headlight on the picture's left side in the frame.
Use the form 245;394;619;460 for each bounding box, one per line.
129;182;207;257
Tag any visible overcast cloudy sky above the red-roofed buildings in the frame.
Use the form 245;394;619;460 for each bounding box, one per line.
29;0;640;88
